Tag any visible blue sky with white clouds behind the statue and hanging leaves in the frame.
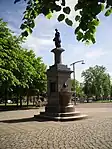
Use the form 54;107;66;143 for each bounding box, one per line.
0;0;112;82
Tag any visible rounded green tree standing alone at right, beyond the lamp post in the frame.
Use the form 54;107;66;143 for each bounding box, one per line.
82;65;111;100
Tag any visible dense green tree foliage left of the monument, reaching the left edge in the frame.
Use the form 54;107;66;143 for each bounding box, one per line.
0;19;46;104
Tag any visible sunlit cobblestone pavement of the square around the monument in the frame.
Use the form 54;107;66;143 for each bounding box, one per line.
0;104;112;149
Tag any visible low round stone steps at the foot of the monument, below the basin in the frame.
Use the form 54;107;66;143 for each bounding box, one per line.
34;105;87;121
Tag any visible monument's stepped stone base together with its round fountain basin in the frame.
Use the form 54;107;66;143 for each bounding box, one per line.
34;91;87;121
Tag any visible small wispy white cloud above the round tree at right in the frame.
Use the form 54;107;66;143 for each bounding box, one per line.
85;49;107;58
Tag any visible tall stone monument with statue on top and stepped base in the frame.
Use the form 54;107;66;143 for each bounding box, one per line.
34;29;86;121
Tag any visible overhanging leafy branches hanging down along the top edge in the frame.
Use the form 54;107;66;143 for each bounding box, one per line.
14;0;112;44
